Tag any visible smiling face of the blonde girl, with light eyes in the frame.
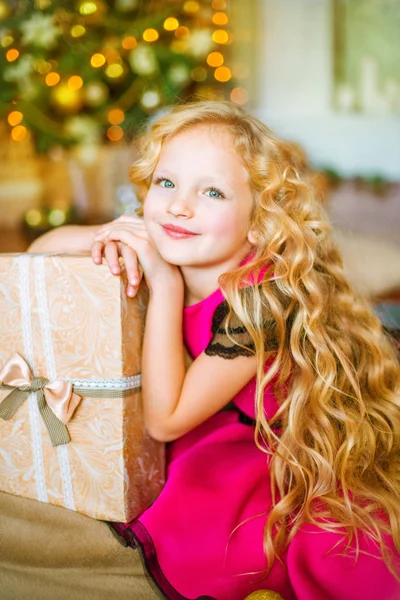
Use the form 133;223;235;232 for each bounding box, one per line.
144;125;253;273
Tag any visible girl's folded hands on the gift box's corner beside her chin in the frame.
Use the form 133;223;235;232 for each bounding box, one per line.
92;215;181;297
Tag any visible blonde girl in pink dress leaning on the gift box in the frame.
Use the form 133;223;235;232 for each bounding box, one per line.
32;102;400;600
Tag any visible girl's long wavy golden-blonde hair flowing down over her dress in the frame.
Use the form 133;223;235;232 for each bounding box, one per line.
130;101;400;572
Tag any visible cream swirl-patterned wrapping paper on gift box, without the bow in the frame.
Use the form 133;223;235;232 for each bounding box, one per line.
0;254;165;521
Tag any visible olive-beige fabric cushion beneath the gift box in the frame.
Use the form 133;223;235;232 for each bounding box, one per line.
0;492;163;600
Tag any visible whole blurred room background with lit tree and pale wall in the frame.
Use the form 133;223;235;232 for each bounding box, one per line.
0;0;400;318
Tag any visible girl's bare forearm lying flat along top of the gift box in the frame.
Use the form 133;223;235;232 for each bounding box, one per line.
27;225;99;254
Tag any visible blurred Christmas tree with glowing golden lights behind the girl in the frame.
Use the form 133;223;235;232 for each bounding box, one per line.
0;0;236;152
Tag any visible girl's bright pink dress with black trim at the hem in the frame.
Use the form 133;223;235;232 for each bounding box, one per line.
114;289;400;600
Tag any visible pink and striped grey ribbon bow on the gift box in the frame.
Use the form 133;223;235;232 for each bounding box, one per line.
0;353;81;446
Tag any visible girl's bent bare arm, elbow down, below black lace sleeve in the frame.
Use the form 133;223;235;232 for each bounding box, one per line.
142;279;256;442
